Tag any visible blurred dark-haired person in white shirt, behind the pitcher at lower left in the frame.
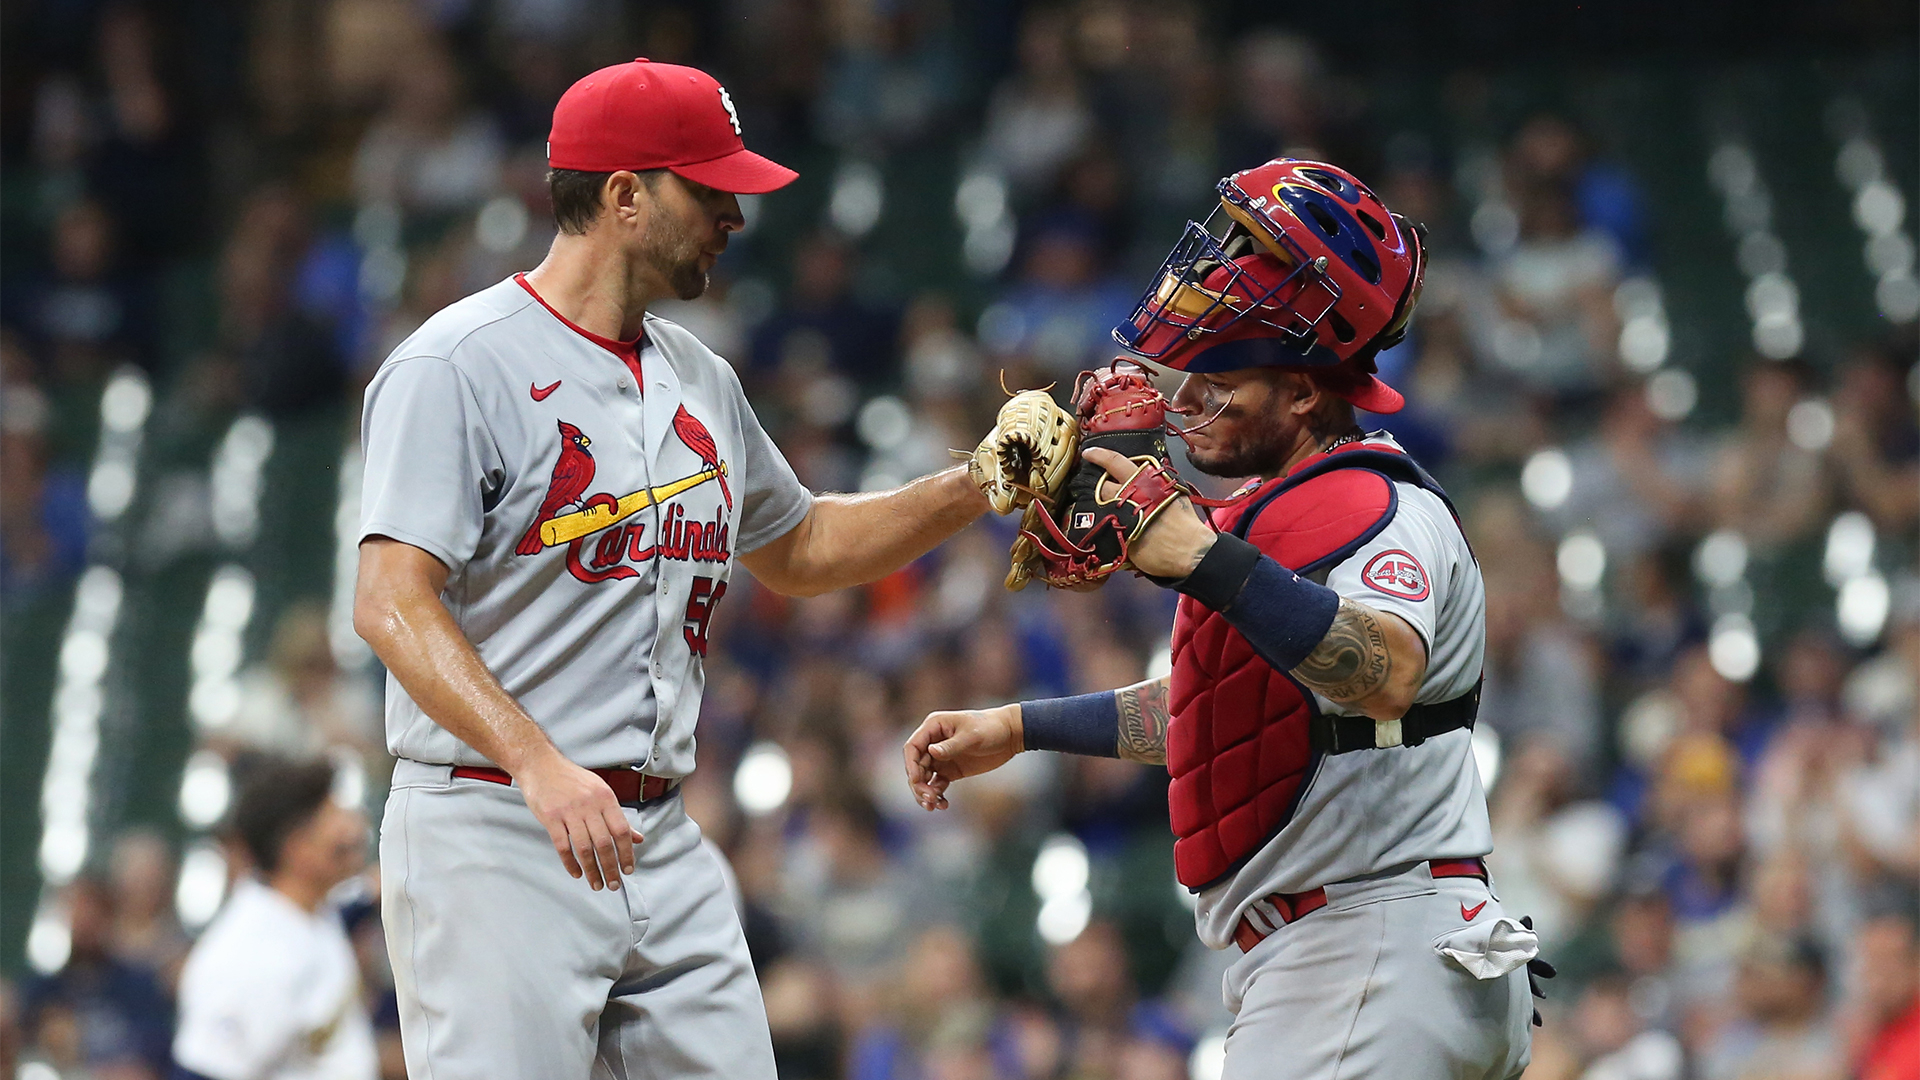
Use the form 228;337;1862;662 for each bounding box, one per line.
173;761;378;1080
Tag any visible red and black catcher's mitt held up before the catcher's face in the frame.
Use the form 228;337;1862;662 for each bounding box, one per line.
1006;361;1190;590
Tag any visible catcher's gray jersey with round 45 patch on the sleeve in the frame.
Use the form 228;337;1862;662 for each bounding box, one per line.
1194;432;1494;949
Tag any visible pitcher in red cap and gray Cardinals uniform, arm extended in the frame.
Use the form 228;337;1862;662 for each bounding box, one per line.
353;60;1071;1080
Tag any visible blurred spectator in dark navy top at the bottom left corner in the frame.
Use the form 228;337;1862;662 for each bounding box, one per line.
21;874;173;1080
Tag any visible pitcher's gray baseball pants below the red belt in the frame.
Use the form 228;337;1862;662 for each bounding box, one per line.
380;759;774;1080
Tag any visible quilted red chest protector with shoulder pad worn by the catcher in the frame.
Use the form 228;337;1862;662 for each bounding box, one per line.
1167;444;1440;892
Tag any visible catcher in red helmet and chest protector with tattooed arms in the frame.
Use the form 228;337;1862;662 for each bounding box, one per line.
904;160;1551;1080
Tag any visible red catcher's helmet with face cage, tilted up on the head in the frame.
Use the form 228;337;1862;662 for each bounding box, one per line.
1114;158;1427;413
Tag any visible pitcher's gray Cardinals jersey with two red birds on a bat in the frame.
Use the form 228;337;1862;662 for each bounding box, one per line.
361;277;812;776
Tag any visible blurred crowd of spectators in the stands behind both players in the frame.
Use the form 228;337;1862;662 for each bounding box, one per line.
0;0;1920;1080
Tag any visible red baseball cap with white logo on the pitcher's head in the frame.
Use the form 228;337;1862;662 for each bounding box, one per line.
547;56;799;194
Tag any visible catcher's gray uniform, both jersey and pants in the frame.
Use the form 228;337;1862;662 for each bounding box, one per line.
1196;434;1538;1080
